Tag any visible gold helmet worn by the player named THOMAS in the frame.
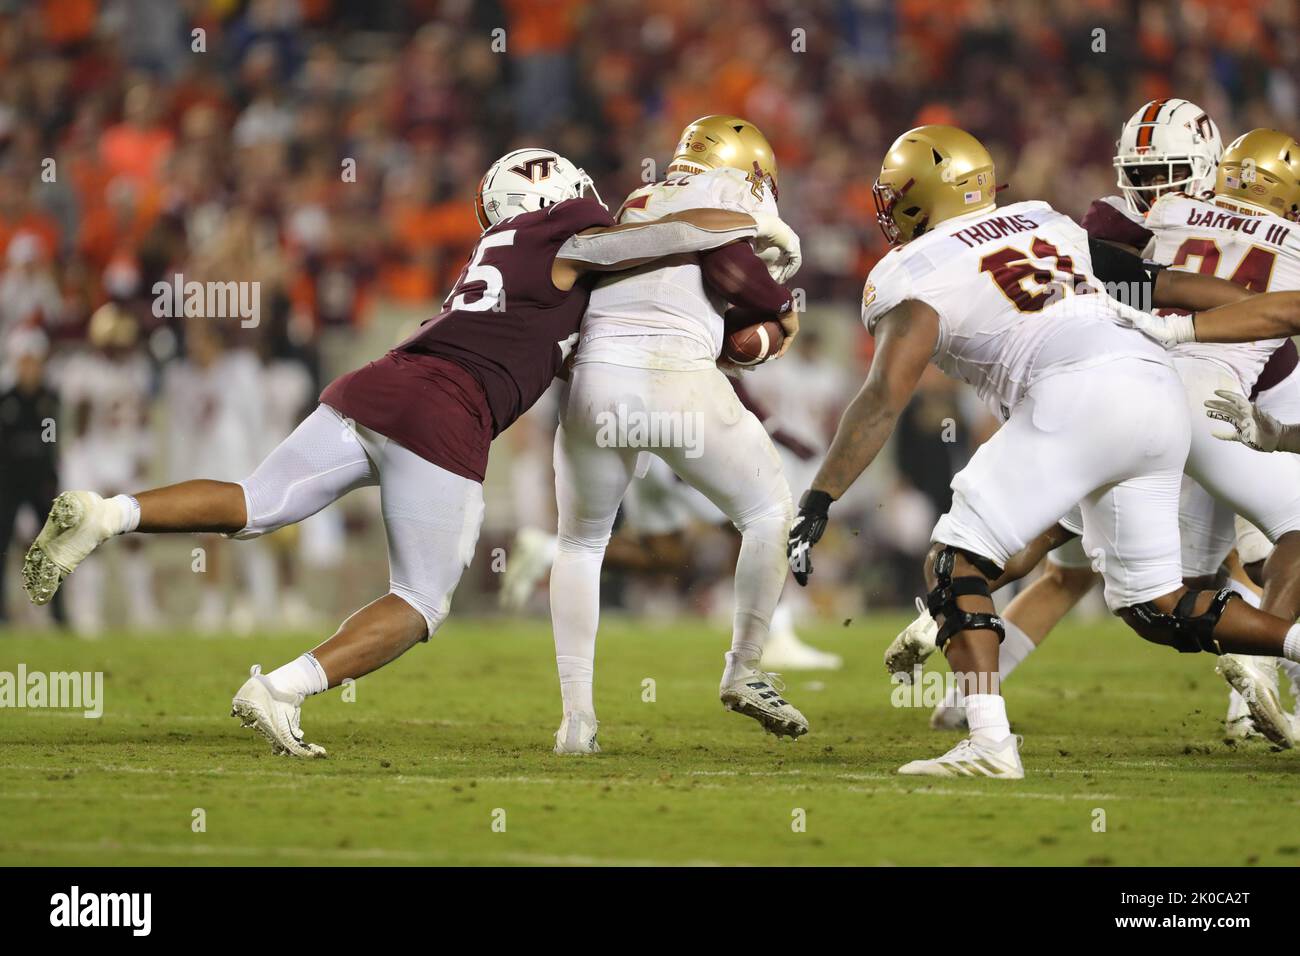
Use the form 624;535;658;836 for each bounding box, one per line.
871;126;997;246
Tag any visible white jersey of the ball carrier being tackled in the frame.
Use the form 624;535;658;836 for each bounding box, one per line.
576;169;776;371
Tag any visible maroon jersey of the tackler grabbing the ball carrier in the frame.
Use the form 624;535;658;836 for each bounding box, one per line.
321;199;614;481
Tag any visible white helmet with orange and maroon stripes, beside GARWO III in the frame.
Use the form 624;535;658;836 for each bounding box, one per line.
1114;98;1223;215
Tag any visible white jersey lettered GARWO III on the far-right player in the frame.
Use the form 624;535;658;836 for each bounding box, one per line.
1147;194;1300;394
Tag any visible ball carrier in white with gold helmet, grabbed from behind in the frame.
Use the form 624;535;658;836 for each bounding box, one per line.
550;116;807;754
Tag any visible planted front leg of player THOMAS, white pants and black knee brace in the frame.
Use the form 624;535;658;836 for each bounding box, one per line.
905;360;1188;778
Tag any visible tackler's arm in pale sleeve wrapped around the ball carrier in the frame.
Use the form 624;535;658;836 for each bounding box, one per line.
551;209;798;289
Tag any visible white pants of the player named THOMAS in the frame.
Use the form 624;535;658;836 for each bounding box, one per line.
932;358;1190;610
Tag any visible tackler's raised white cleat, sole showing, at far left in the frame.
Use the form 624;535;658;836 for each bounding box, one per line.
22;492;121;605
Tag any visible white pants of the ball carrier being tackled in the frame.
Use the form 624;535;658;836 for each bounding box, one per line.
551;362;793;683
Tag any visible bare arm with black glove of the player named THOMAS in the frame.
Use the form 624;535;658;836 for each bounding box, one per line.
787;299;939;584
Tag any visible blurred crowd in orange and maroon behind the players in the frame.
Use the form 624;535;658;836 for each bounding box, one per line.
0;0;1300;630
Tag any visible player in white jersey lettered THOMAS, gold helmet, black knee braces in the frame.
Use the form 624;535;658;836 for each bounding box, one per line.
788;126;1300;778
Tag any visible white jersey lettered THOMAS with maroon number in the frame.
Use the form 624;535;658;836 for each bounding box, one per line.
862;202;1166;418
